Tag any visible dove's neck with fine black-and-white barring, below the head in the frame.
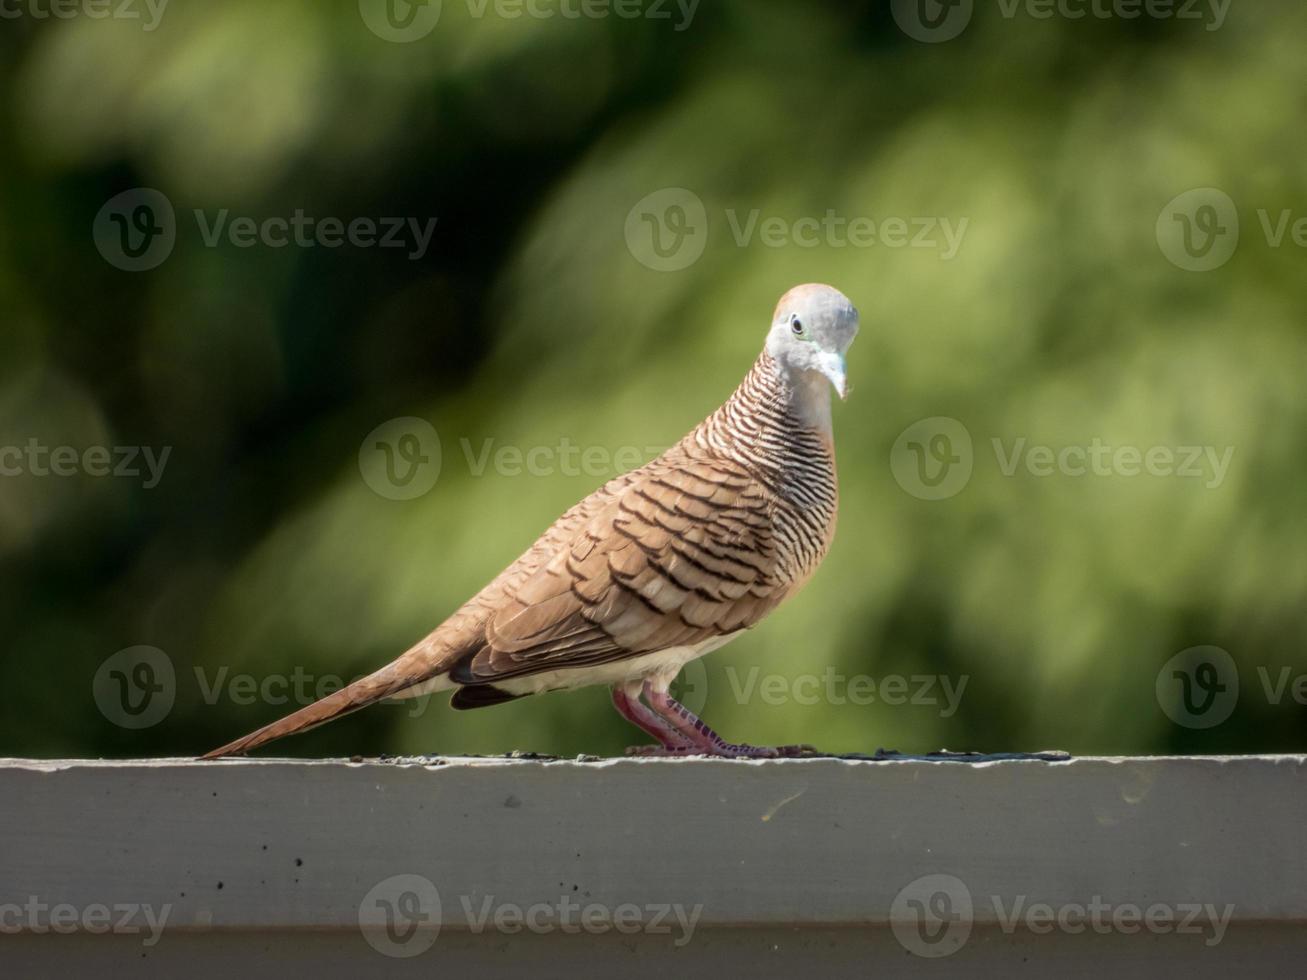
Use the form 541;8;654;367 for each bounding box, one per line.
691;350;835;507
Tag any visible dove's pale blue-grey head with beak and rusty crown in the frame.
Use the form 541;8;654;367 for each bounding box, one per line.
767;282;857;399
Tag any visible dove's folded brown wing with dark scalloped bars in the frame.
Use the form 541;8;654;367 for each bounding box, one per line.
450;457;791;685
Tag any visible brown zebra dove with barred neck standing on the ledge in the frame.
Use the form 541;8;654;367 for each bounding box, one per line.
201;284;859;759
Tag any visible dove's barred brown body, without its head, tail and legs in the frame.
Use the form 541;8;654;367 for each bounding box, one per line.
407;354;836;686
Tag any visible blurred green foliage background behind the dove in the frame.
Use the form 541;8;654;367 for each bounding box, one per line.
0;0;1307;757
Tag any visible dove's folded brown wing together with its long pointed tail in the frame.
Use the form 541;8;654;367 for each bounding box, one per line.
204;447;795;758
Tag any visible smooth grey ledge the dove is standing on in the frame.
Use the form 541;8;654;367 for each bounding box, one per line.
0;755;1307;976
